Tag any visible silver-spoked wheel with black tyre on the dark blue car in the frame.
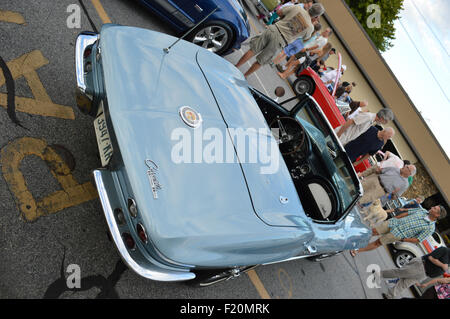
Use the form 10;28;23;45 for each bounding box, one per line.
189;21;233;55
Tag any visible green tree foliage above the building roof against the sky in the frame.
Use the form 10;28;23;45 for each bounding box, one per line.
345;0;403;52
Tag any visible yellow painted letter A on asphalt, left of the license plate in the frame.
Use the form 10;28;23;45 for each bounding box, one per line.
0;50;75;120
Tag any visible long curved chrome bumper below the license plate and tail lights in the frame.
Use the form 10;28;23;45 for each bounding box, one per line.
92;170;195;281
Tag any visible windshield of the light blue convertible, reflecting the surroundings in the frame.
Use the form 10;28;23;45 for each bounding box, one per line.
296;101;359;212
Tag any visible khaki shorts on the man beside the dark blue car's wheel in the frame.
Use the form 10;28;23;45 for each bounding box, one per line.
250;25;285;65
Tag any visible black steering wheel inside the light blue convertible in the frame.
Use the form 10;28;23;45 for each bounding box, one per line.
269;116;306;155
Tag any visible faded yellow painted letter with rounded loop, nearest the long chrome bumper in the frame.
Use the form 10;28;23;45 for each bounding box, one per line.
0;137;98;221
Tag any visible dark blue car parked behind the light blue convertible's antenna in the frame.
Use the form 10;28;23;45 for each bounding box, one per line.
139;0;250;55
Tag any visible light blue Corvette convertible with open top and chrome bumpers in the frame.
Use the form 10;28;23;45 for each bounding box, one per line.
76;24;370;286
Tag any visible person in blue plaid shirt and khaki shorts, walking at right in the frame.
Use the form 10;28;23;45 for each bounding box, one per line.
350;205;447;257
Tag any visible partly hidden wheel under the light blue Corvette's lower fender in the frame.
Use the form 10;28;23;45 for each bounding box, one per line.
186;266;256;288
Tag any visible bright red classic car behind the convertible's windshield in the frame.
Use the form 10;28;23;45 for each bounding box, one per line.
292;67;371;172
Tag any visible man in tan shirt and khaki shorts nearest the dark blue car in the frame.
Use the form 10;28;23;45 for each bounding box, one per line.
235;3;325;78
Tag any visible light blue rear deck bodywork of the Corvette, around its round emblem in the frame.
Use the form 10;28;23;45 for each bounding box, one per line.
100;26;312;266
